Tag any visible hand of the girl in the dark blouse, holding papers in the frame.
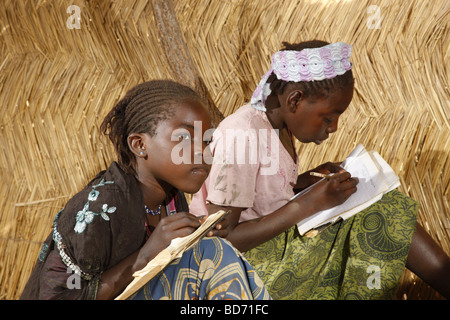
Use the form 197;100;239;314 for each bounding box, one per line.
135;212;201;269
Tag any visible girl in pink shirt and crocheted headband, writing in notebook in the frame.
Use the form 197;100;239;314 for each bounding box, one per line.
190;41;450;299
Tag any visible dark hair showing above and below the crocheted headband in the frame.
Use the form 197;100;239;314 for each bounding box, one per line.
267;40;354;98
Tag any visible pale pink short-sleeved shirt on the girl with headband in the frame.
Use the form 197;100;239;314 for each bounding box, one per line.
190;104;298;222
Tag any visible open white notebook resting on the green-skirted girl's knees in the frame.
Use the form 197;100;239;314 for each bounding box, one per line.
291;144;400;235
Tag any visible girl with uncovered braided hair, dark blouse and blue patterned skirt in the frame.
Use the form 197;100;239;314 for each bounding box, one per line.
21;80;270;299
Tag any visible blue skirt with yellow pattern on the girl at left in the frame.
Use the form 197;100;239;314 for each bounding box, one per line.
131;237;270;300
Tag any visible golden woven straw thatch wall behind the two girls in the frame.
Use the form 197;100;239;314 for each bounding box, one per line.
0;0;450;299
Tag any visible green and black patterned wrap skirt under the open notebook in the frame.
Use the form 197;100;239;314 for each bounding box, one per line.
245;190;418;300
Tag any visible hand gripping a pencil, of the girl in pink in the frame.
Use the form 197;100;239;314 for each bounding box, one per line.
298;170;359;212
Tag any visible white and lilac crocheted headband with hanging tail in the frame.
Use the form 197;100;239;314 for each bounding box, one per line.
250;42;352;111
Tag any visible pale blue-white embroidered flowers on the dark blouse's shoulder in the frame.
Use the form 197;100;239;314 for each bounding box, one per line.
73;179;117;234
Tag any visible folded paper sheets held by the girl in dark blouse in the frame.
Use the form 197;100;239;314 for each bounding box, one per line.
115;210;230;300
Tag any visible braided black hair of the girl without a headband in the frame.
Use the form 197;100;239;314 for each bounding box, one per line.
100;80;204;175
